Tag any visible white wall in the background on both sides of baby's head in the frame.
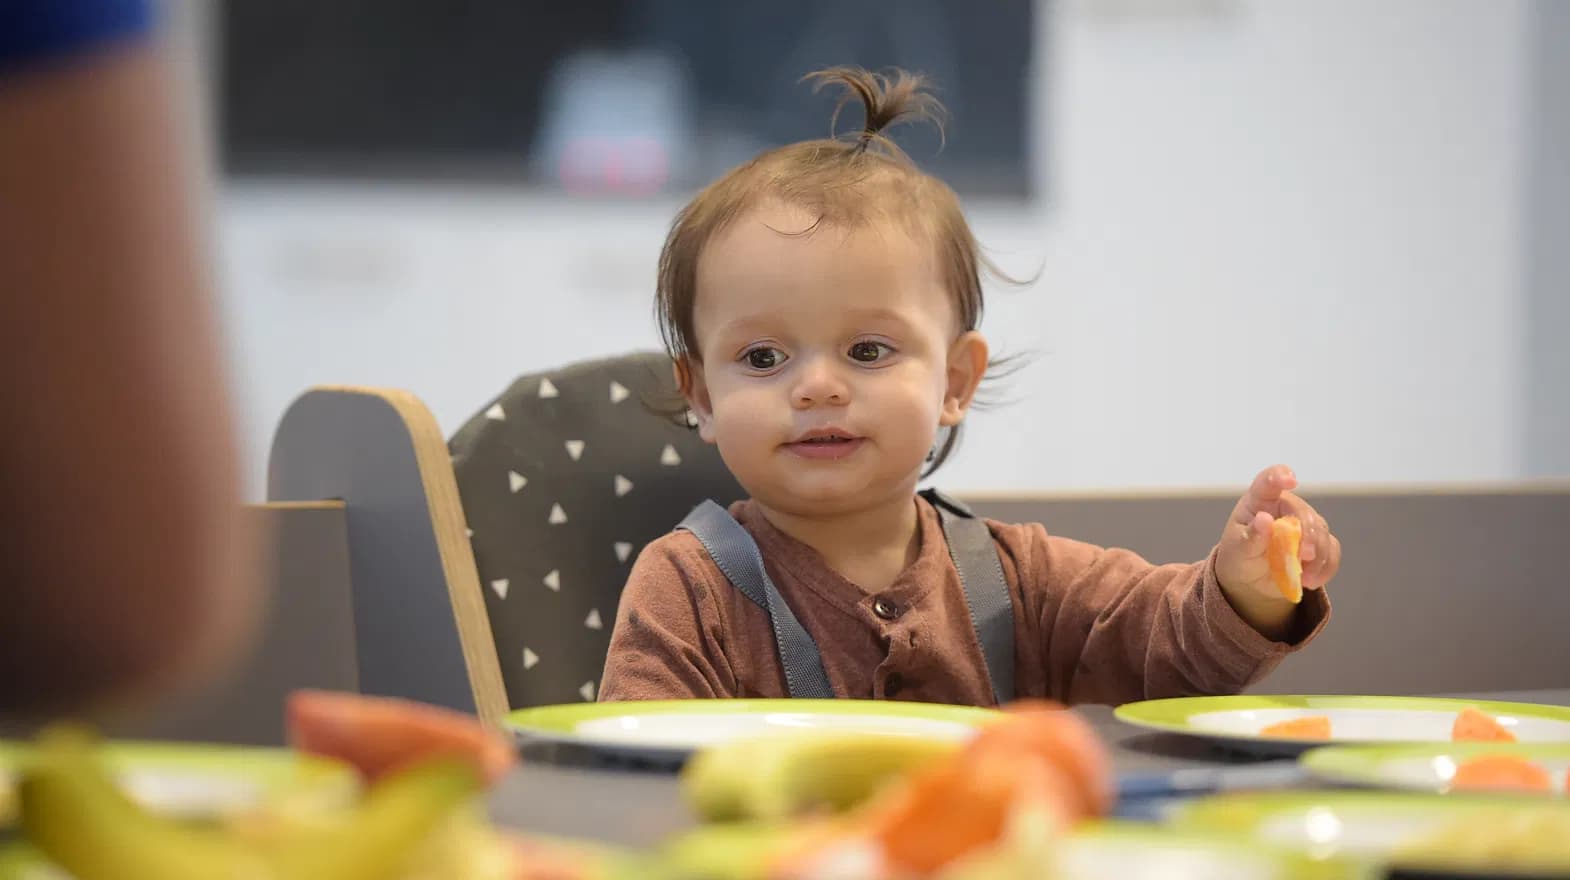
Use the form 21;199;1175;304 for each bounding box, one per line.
220;0;1528;491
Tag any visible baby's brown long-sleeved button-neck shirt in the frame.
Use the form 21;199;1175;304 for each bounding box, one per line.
600;497;1330;706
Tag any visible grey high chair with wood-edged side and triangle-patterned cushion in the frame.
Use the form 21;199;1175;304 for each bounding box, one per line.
268;353;741;722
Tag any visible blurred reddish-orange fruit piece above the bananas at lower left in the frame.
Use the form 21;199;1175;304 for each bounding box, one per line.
287;690;518;783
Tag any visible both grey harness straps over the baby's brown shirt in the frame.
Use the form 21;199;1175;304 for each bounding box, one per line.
677;489;1014;704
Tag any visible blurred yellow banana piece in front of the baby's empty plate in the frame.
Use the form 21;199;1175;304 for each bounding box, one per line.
681;731;961;822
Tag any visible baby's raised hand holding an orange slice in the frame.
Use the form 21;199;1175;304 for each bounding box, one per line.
1215;464;1341;640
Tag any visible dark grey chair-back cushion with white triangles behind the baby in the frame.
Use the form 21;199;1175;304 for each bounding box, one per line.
449;353;743;707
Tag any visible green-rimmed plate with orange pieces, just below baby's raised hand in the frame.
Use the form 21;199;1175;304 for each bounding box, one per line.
1116;696;1570;755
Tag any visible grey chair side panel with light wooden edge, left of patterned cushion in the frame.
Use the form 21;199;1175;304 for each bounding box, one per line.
267;387;507;723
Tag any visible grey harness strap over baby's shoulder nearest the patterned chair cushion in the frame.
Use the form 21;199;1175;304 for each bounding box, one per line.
677;500;835;698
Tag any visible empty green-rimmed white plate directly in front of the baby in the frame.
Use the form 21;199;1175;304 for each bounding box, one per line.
506;700;999;761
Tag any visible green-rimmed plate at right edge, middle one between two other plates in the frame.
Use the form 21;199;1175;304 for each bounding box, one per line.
1300;742;1570;797
